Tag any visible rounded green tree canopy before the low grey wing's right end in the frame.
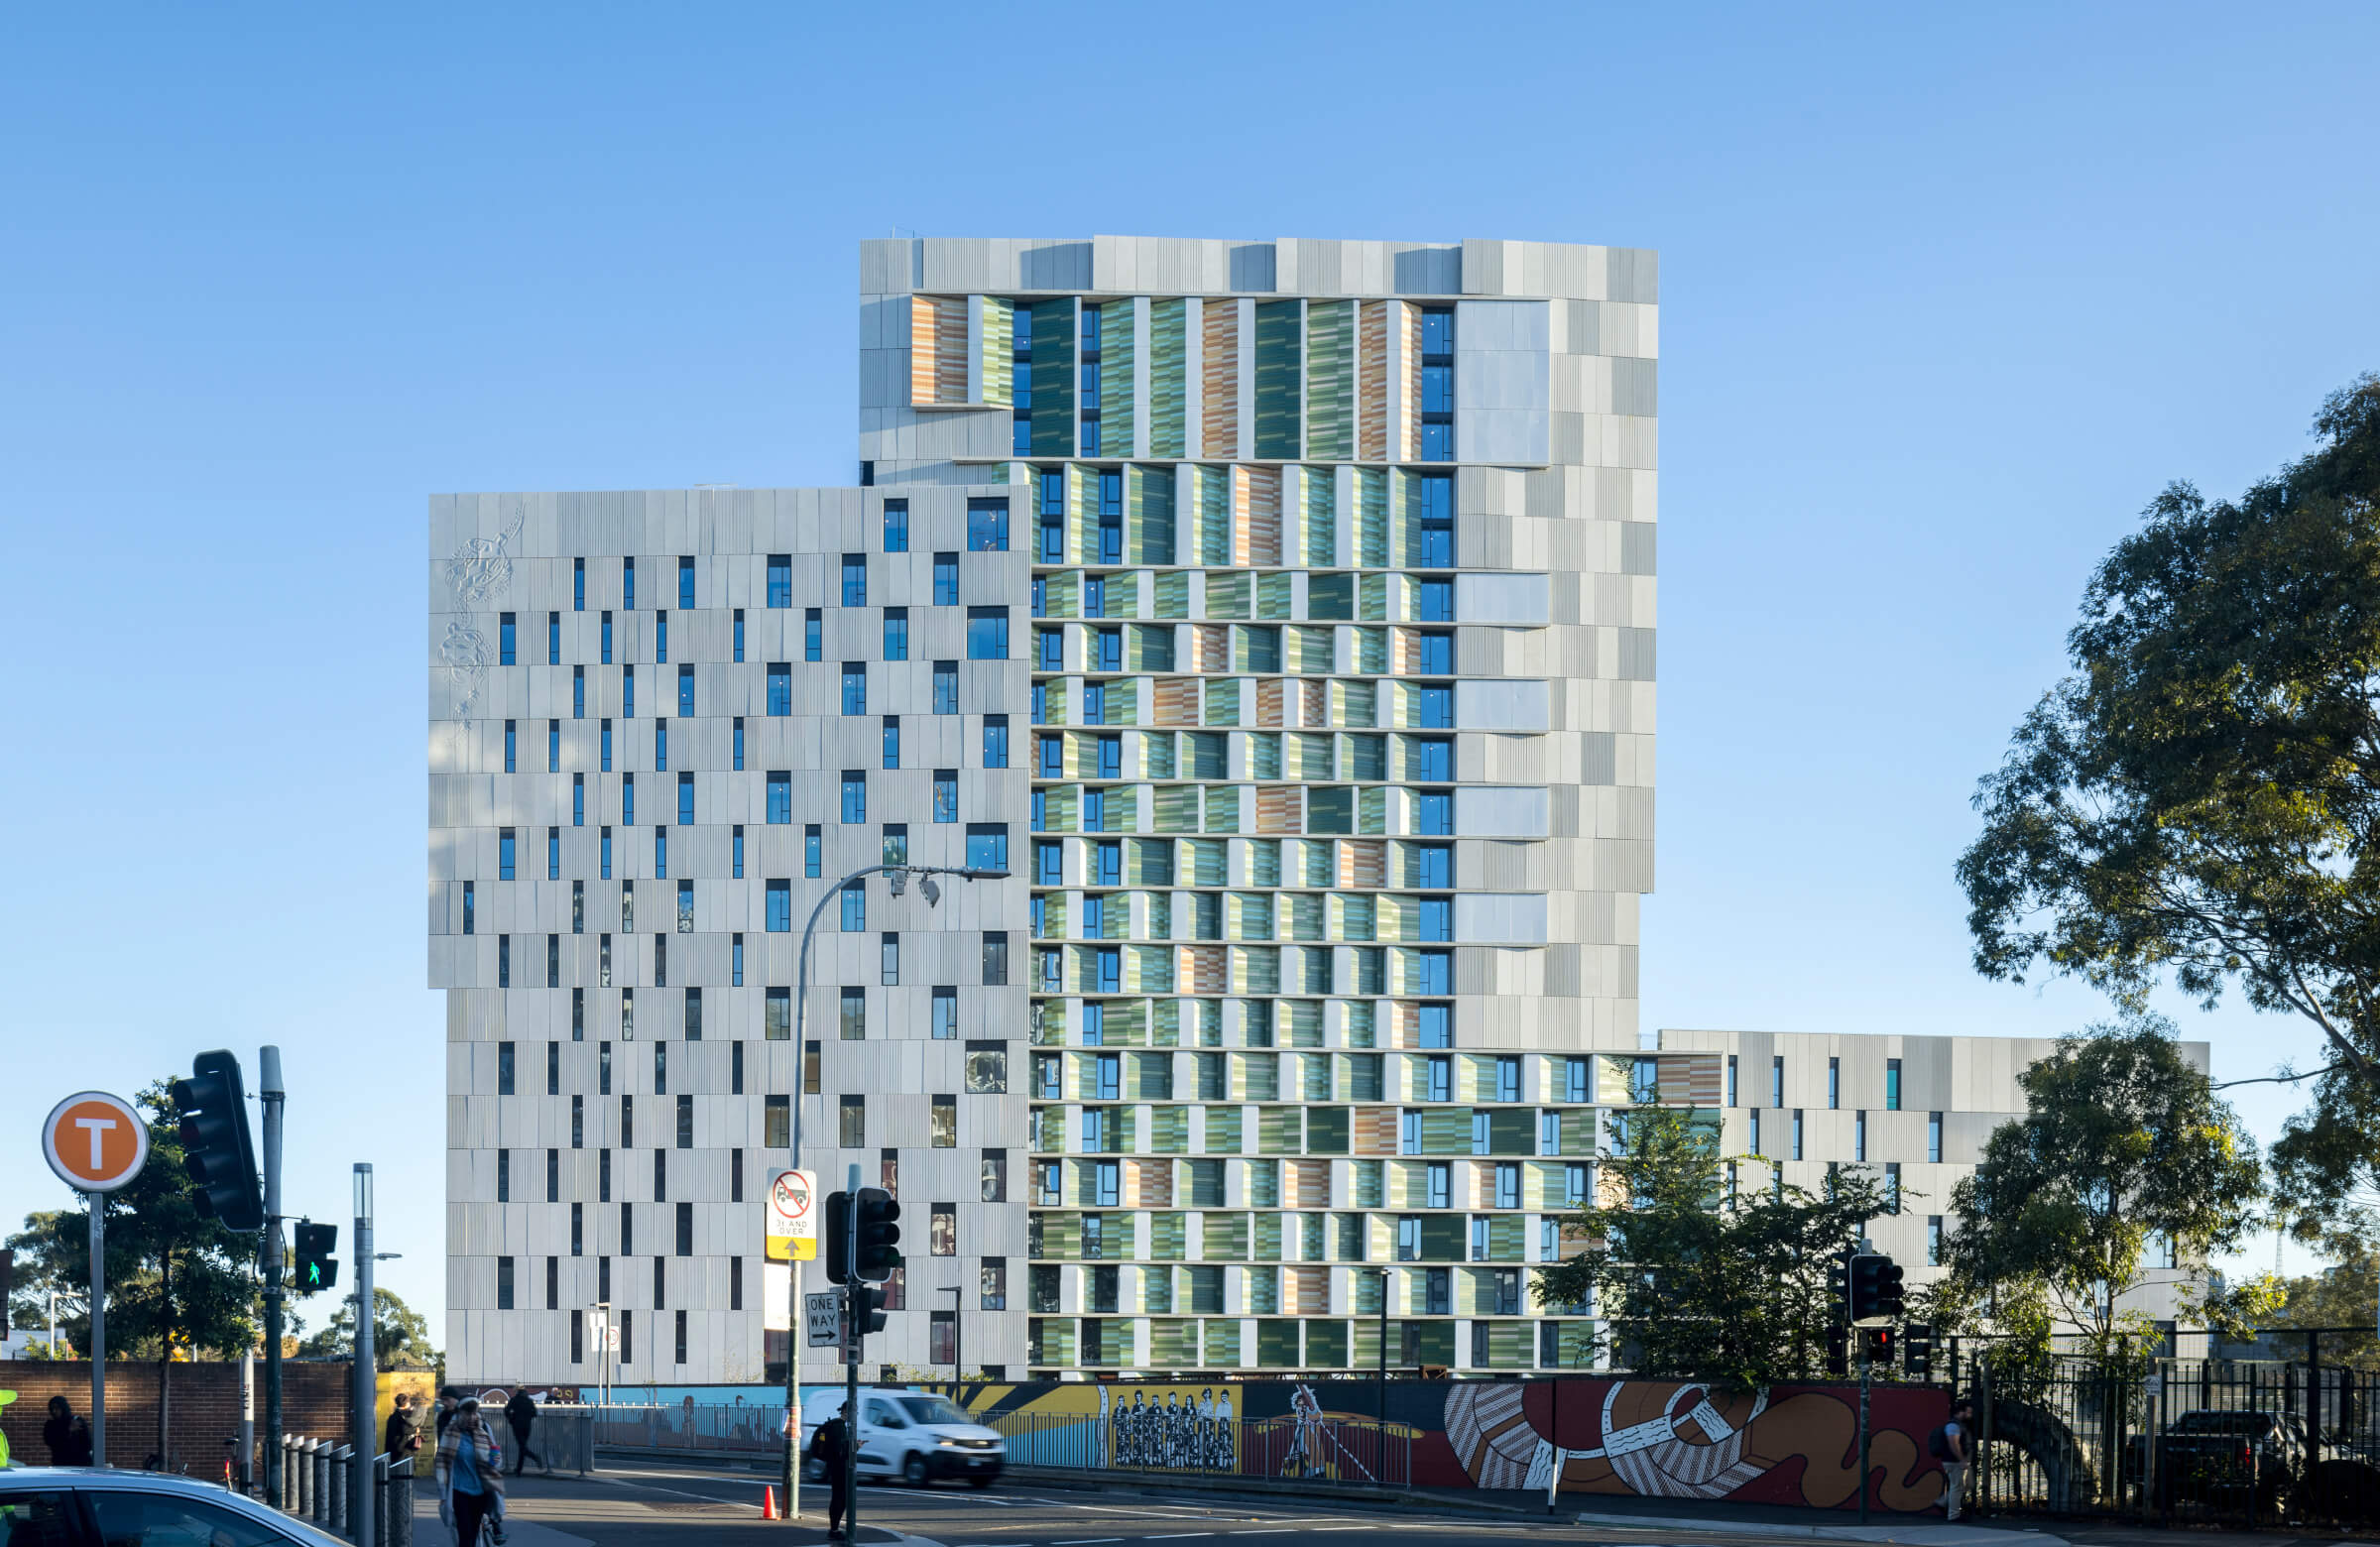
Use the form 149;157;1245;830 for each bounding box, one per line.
1945;1016;2263;1352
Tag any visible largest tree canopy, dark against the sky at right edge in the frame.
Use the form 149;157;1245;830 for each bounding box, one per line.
1959;376;2380;1233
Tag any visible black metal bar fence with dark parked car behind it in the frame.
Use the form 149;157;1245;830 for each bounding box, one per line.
1959;1338;2380;1525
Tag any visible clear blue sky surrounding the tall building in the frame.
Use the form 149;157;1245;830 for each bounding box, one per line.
0;5;2380;1321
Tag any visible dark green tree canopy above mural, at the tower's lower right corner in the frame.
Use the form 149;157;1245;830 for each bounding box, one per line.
1530;1107;1892;1387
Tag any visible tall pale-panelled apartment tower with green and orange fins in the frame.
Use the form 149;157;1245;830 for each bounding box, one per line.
428;238;1659;1382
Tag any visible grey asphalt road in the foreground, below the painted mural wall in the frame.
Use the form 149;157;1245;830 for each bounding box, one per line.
449;1464;1952;1547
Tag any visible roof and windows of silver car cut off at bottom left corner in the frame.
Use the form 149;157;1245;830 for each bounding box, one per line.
0;1466;352;1547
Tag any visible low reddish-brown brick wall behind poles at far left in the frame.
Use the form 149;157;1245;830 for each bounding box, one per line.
0;1359;350;1476
